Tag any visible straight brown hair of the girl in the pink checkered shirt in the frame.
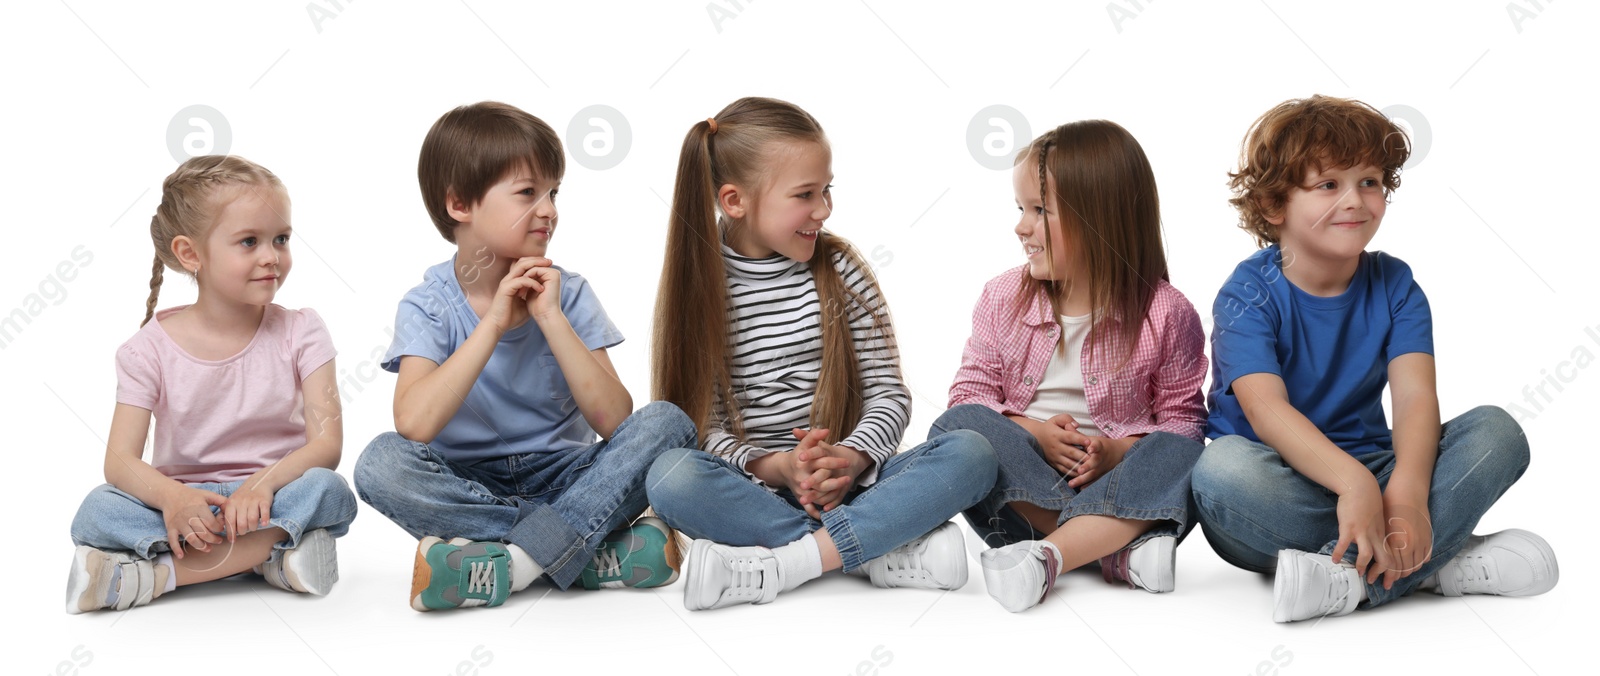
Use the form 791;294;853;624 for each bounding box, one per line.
1016;120;1168;368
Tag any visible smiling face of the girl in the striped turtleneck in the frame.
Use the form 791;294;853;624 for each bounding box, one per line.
718;141;834;263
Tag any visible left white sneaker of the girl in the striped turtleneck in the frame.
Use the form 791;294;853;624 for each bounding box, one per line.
683;540;784;610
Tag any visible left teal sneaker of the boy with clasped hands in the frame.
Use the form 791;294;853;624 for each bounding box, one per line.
411;535;510;612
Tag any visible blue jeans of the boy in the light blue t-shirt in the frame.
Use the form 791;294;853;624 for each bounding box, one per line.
355;402;696;589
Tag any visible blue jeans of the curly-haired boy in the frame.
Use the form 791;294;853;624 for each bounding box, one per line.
1194;405;1528;607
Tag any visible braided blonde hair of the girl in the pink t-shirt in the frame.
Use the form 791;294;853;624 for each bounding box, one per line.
139;155;288;327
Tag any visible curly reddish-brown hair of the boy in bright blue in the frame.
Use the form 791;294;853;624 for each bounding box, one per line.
1227;95;1411;248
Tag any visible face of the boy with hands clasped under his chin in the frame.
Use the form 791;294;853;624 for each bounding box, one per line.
450;168;560;260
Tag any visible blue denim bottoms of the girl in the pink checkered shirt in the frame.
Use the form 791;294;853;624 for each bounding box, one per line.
930;404;1205;546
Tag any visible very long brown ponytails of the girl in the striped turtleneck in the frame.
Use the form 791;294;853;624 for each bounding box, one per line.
651;98;899;442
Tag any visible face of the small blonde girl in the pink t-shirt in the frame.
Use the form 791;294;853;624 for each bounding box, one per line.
197;186;291;306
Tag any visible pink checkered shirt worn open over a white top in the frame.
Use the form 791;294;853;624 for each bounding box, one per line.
950;266;1206;441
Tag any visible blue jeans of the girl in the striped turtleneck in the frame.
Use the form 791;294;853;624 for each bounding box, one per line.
646;433;995;572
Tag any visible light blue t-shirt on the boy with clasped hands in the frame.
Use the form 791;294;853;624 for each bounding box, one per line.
382;258;622;463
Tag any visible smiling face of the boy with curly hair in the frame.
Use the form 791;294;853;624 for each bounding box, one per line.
1267;165;1389;261
